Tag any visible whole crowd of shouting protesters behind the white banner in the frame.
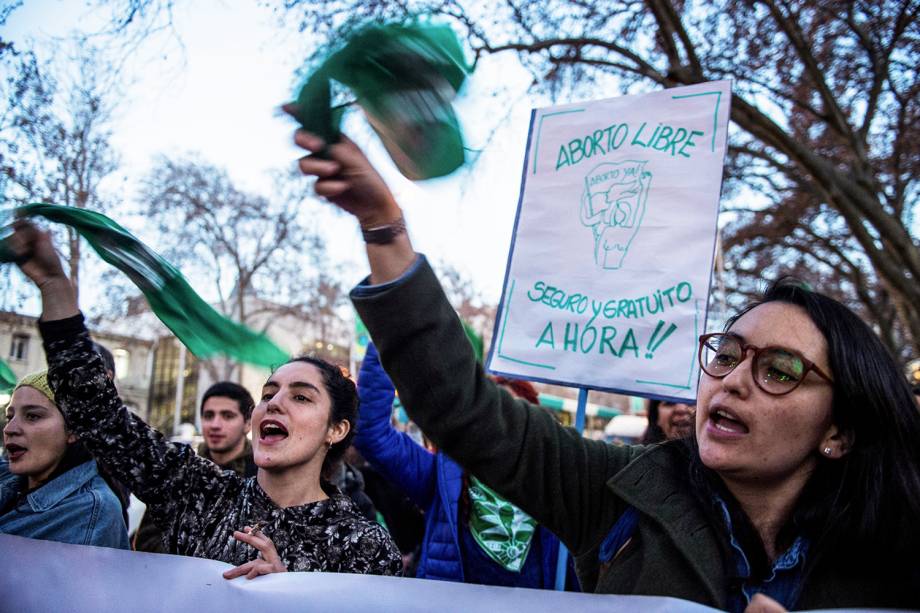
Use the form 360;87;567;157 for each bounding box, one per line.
0;119;920;611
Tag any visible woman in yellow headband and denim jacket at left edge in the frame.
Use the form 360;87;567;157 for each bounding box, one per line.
0;372;128;549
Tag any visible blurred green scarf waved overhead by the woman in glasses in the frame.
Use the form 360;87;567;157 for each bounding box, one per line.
294;23;471;180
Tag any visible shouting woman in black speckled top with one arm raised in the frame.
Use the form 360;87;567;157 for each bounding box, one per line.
4;222;402;578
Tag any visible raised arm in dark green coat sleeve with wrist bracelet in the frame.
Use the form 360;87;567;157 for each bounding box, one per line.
295;131;638;553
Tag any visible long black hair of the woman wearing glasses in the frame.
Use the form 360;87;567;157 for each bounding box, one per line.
689;278;920;564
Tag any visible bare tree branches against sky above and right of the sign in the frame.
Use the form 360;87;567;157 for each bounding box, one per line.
278;0;920;354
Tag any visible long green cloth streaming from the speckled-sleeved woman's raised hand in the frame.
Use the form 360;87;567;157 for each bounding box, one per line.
0;203;289;367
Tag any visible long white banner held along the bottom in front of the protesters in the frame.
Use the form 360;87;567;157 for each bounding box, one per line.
0;535;715;613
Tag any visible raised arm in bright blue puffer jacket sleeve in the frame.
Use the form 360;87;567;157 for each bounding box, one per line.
354;343;437;509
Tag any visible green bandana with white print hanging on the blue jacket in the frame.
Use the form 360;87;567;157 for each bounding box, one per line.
468;475;537;573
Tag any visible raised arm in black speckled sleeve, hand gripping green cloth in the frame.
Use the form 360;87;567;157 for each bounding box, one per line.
8;221;230;504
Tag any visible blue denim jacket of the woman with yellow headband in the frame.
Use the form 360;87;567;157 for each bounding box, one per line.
0;459;128;549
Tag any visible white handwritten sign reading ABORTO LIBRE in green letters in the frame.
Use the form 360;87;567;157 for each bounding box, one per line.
489;81;731;400
